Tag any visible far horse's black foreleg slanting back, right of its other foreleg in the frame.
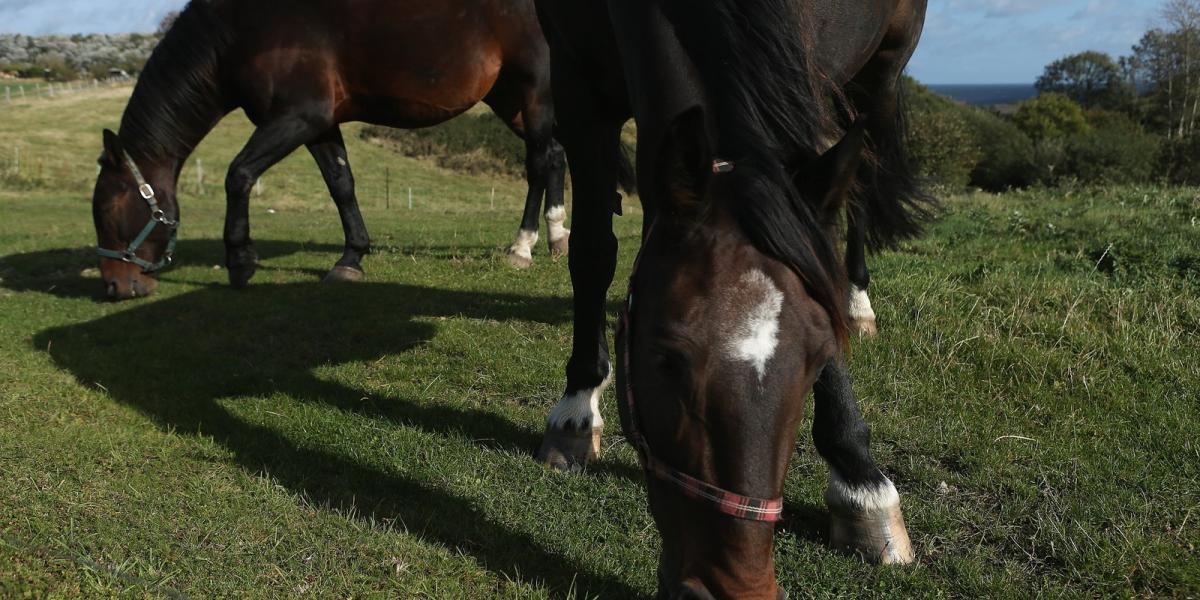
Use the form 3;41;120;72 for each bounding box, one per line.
308;126;371;282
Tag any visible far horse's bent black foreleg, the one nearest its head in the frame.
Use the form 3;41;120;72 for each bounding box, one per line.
224;118;314;288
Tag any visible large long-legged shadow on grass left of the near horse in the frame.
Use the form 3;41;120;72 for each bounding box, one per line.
32;282;637;598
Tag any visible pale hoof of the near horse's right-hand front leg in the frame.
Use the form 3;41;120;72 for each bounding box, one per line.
829;504;914;564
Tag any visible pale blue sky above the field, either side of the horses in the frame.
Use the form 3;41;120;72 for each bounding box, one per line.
0;0;1160;84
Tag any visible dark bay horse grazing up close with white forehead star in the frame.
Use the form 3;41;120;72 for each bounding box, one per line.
538;0;925;599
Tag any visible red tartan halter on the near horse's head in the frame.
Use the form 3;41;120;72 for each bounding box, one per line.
617;161;784;523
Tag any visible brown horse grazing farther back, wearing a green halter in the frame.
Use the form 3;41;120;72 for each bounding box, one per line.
92;0;569;298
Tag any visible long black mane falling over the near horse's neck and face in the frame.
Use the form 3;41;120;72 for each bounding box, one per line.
667;0;851;338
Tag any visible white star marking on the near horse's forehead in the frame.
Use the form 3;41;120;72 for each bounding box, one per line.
726;269;784;380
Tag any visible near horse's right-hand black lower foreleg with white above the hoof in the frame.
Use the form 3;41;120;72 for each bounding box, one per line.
812;359;914;564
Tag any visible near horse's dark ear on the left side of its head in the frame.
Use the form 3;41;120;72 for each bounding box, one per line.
658;107;713;209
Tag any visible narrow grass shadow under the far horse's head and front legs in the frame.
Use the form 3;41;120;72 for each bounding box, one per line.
0;239;343;300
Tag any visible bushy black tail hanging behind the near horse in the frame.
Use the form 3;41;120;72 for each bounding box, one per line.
850;83;938;250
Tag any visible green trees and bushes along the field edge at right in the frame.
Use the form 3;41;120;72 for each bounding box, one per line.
908;0;1200;190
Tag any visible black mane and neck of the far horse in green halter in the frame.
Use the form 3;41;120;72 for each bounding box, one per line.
120;0;232;158
